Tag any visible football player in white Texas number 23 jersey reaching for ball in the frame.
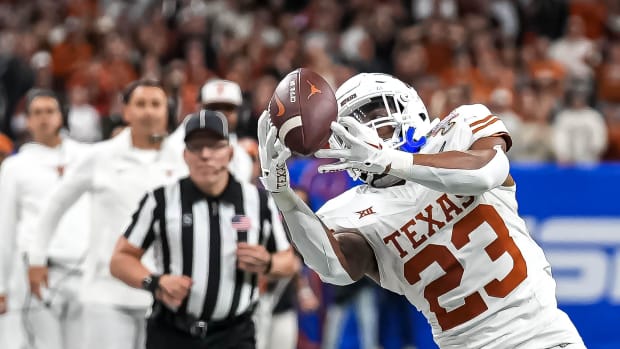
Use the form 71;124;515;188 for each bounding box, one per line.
258;74;585;349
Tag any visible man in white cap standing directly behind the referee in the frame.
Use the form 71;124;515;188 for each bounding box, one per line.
170;79;254;182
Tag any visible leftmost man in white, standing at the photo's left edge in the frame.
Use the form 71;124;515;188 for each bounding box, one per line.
0;89;89;349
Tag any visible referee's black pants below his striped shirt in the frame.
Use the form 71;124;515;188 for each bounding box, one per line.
146;317;256;349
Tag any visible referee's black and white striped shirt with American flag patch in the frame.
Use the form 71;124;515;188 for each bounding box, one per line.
125;176;289;321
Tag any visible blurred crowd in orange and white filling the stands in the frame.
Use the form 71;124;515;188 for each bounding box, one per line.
0;0;620;163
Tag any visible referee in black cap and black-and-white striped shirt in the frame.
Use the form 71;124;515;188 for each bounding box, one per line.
110;110;299;349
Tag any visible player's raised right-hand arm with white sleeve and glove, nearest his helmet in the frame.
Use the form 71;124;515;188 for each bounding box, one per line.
315;118;509;195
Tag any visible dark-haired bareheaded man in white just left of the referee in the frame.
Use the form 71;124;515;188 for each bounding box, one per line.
29;80;187;349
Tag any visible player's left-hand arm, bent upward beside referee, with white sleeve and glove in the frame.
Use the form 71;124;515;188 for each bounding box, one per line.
258;113;376;285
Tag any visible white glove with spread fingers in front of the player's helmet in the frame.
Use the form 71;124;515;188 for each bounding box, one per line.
314;117;413;174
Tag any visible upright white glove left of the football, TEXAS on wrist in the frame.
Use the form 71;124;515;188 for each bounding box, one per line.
258;111;291;193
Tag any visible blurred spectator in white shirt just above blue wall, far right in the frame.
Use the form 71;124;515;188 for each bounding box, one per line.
552;81;607;164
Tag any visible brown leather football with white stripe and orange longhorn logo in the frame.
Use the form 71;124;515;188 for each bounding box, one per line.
268;68;338;156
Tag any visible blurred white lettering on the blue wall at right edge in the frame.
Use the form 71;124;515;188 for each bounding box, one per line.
527;217;620;305
